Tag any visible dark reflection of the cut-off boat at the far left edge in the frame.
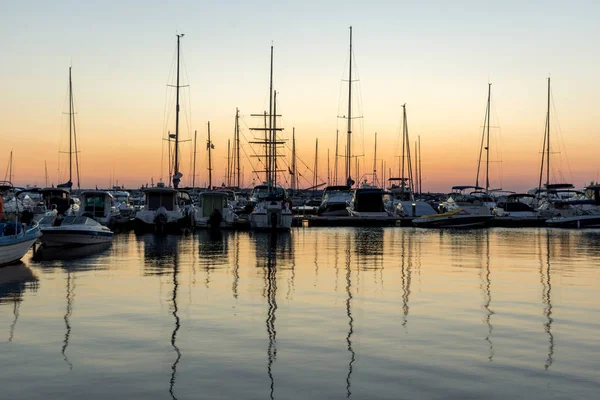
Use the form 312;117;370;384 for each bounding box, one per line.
0;262;39;342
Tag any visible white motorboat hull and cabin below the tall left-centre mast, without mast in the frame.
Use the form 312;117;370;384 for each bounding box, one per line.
134;186;195;233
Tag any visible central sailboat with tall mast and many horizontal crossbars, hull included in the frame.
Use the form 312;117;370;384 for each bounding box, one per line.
248;46;292;230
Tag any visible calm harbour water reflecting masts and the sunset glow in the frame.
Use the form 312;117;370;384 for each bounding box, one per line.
0;228;600;399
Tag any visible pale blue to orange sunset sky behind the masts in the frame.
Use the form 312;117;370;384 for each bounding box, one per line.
0;0;600;191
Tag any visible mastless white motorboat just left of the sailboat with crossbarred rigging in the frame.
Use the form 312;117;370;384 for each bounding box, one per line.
194;190;238;229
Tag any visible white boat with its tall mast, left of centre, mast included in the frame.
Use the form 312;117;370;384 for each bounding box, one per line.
134;34;194;233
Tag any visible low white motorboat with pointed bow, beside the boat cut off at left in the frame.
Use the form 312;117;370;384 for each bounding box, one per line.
39;215;113;247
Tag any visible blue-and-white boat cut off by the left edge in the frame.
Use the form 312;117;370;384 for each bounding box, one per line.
0;181;41;266
